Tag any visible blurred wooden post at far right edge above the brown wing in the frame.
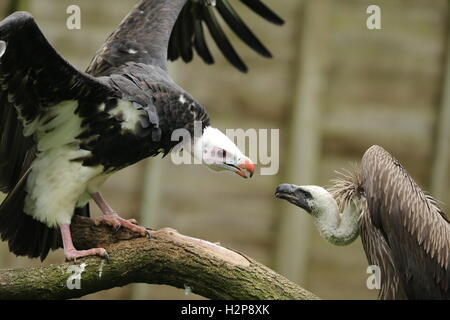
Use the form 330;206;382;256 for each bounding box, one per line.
431;10;450;200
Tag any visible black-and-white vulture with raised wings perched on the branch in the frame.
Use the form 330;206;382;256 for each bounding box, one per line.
0;0;282;260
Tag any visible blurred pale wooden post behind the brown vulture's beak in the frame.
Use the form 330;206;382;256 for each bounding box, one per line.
275;0;329;283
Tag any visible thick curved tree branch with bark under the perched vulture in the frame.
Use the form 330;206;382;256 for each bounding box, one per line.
0;216;317;300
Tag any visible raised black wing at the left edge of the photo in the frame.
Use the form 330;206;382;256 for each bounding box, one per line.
0;12;112;192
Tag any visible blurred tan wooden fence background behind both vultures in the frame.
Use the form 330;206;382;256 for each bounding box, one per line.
0;0;450;299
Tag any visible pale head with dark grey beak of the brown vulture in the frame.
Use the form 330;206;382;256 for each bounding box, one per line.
275;184;338;216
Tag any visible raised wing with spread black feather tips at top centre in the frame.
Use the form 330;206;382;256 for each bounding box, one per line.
87;0;283;76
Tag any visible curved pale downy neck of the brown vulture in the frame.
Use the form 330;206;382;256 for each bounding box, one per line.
313;199;359;246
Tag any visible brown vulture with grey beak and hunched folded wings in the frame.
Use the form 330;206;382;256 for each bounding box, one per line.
275;146;450;299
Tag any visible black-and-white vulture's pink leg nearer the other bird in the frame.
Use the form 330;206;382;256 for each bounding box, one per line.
91;192;150;238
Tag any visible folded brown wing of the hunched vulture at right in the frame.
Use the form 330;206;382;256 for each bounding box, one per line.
362;146;450;299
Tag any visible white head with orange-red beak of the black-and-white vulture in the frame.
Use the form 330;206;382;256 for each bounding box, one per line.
191;127;255;178
